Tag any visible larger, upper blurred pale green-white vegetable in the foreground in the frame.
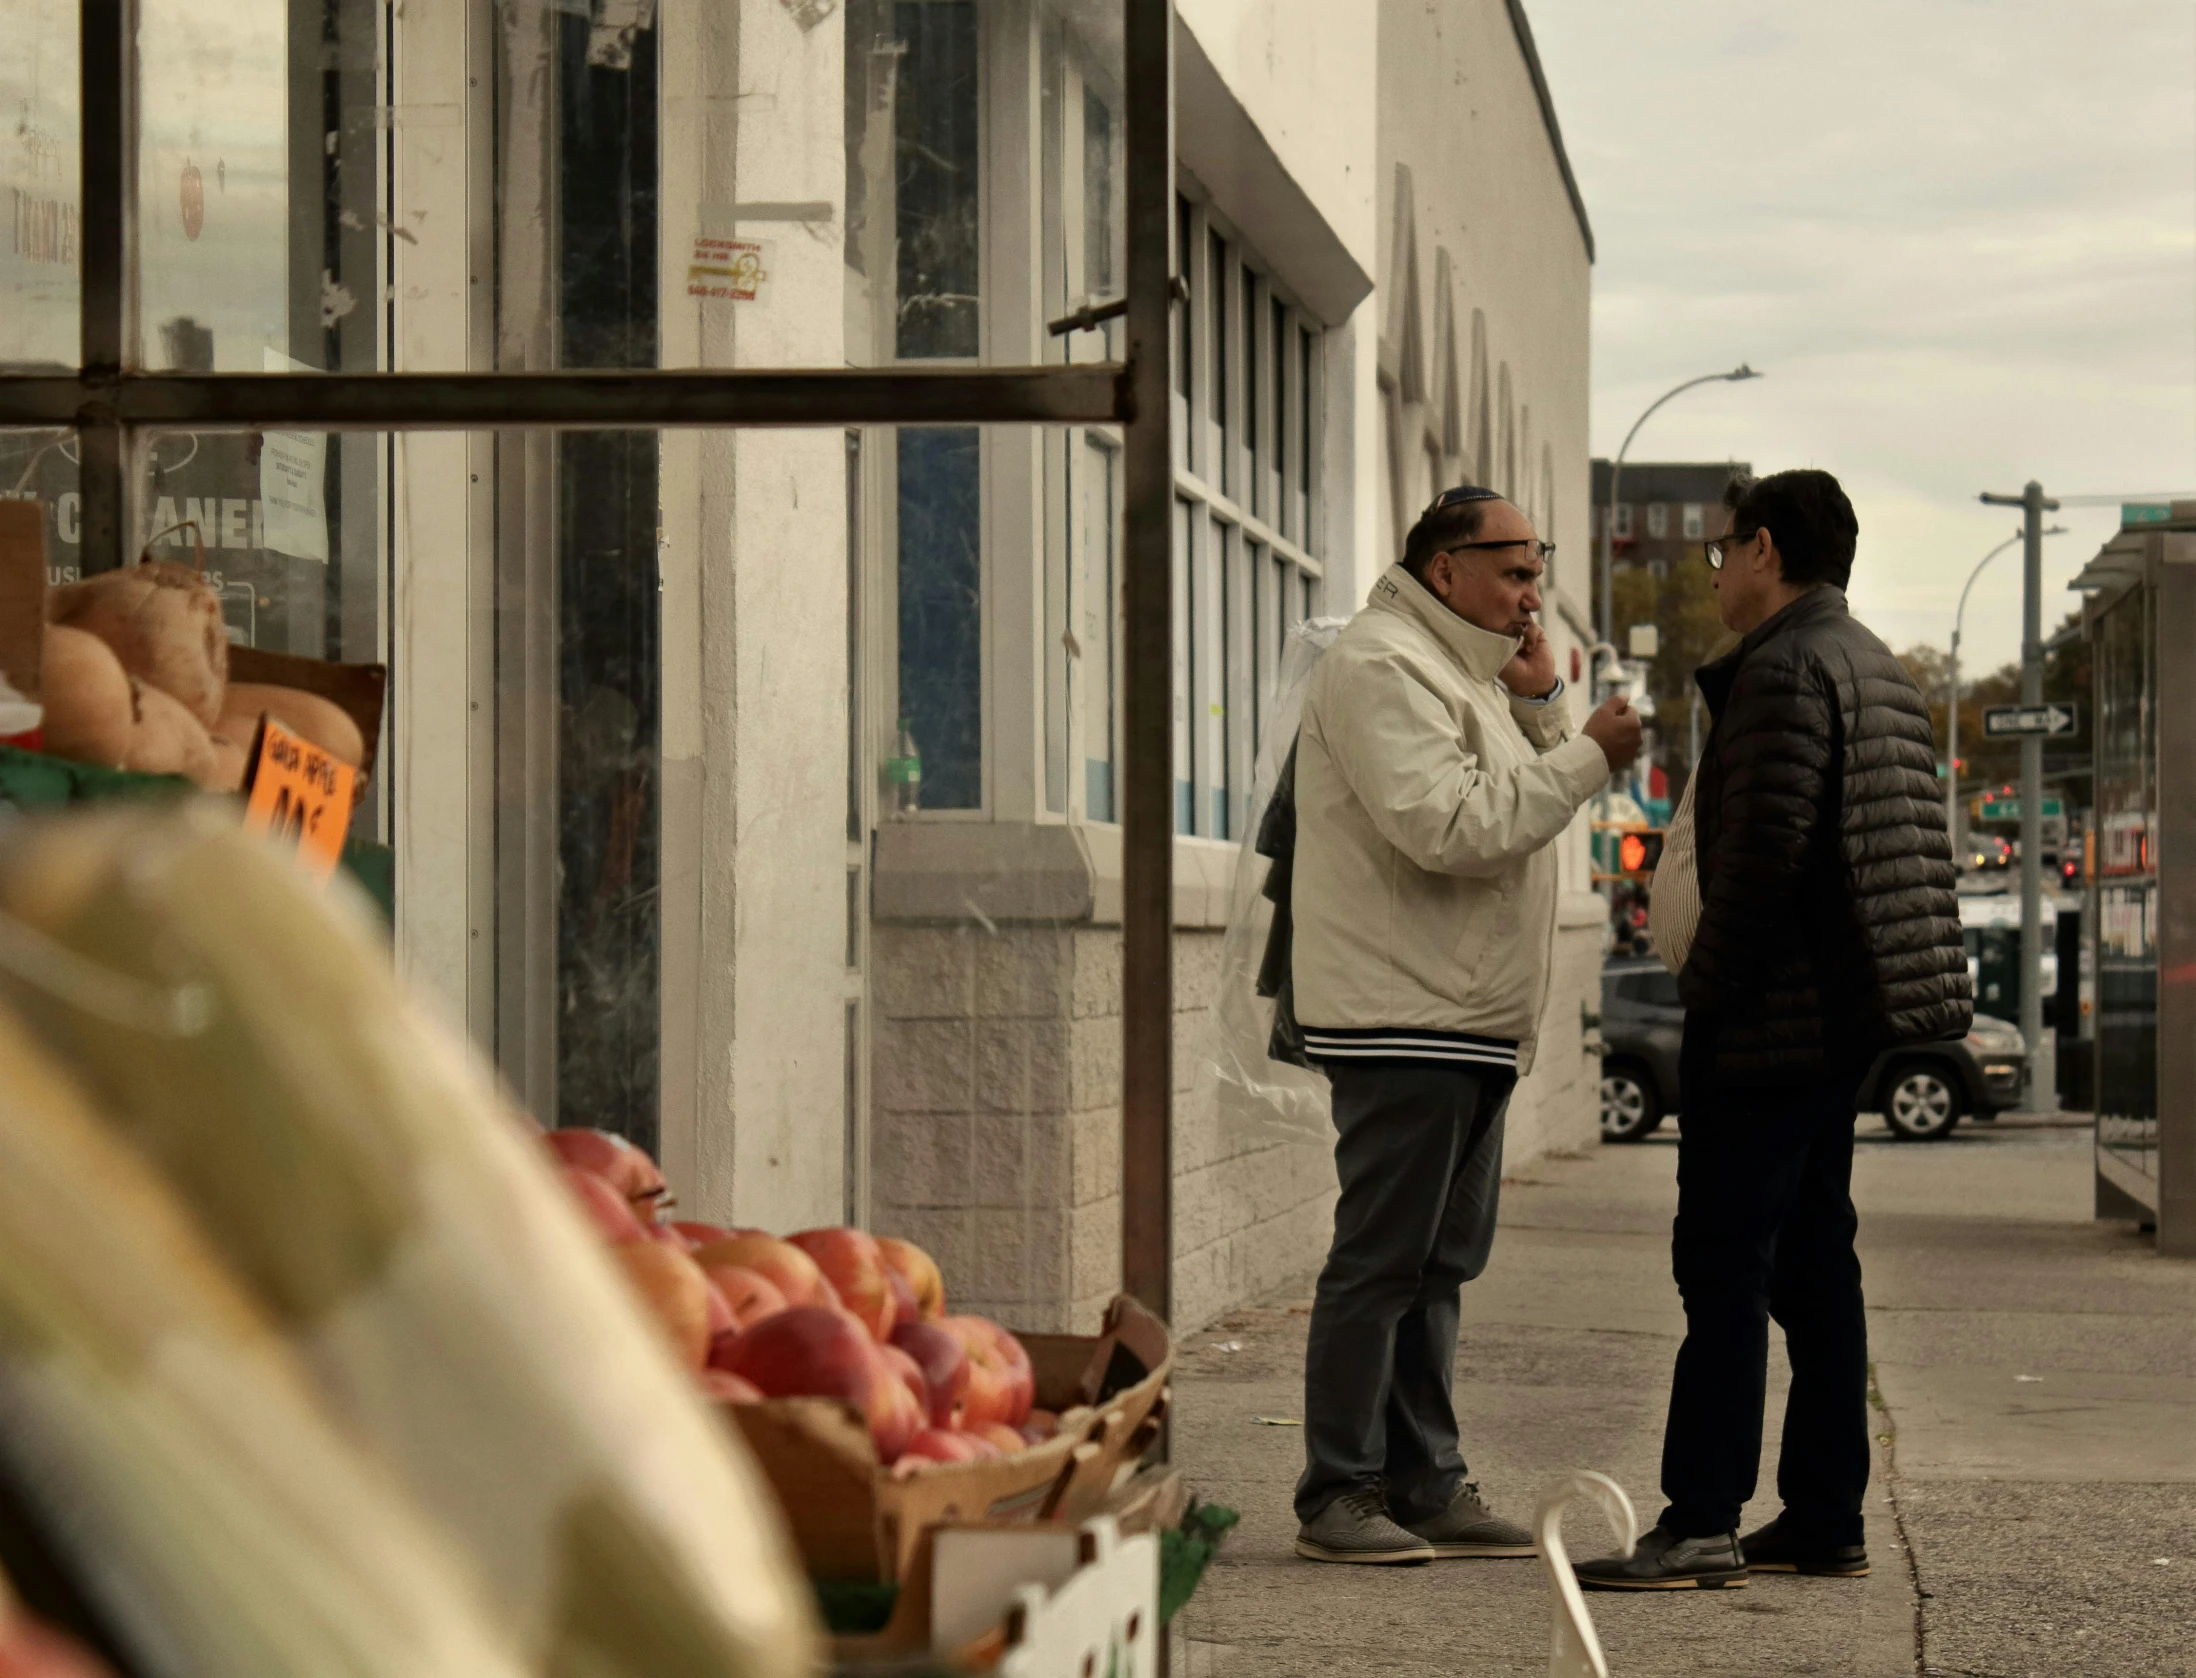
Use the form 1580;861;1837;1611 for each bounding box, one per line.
0;810;817;1678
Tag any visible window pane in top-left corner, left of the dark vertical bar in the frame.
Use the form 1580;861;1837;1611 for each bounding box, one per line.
0;0;83;371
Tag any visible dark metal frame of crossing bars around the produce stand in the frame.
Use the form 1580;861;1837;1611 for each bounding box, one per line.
34;0;1175;1316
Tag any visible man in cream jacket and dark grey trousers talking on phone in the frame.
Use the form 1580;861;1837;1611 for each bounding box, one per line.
1291;485;1640;1562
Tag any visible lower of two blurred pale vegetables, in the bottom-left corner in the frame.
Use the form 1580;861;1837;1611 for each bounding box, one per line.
0;983;523;1678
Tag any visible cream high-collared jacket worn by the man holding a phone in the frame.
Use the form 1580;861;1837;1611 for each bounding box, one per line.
1289;564;1610;1074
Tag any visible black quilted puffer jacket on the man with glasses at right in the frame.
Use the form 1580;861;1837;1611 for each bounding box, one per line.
1678;586;1974;1087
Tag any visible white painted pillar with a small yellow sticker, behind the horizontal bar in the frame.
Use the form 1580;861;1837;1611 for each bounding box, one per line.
661;7;845;1230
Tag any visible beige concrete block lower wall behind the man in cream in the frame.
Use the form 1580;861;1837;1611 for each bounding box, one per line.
870;904;1601;1333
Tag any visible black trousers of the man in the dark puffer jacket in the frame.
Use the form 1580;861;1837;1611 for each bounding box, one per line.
1660;1021;1869;1546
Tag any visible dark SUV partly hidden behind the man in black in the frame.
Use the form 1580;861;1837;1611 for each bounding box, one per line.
1601;960;2027;1142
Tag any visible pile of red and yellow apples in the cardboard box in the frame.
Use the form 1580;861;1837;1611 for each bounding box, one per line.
545;1129;1058;1474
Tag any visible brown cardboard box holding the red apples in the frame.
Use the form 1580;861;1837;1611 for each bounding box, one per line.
727;1296;1175;1584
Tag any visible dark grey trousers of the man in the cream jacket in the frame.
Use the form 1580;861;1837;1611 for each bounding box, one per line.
1296;1061;1517;1520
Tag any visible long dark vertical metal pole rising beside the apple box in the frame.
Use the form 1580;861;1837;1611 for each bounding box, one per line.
1120;0;1175;1320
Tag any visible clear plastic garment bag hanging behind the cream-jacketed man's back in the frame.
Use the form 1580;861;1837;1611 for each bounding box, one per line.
1197;617;1346;1142
